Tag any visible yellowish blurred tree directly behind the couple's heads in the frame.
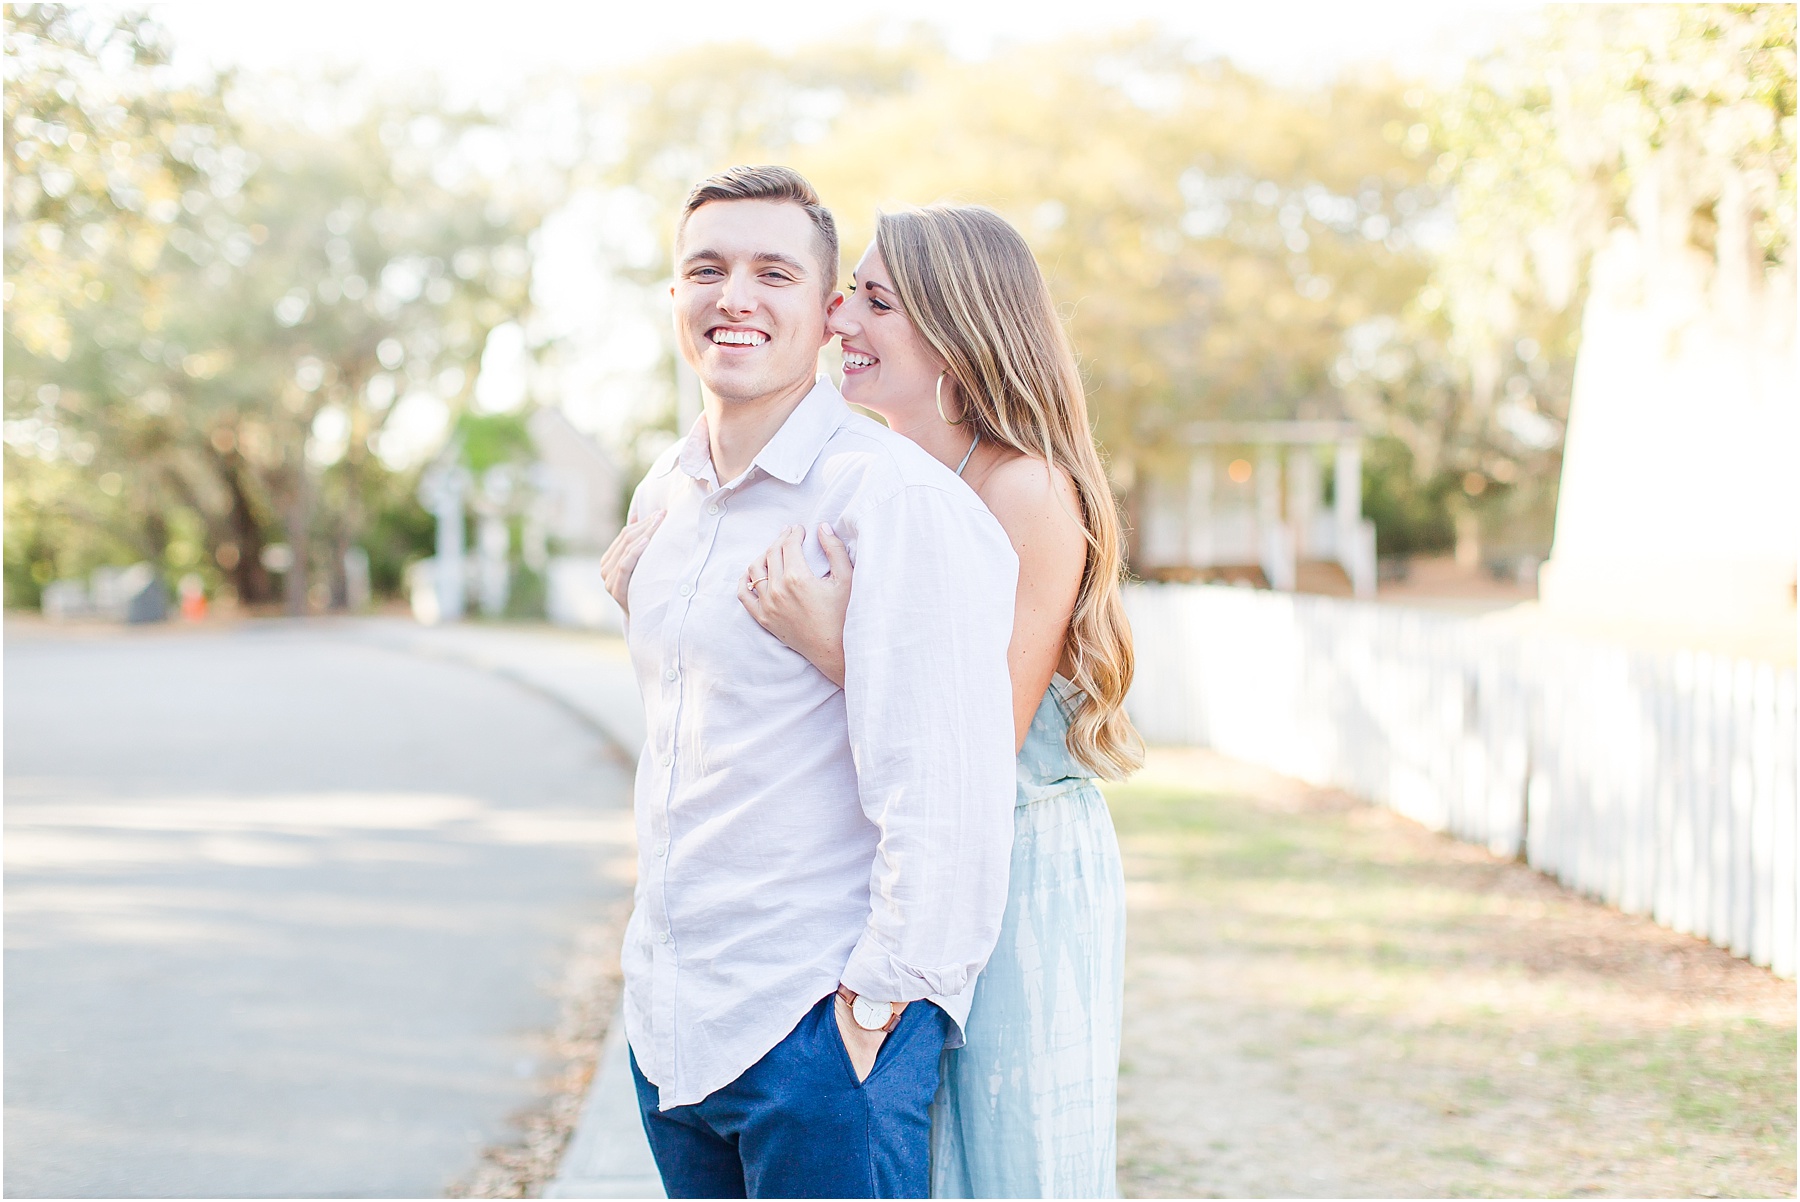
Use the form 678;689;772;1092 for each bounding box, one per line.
583;31;1436;565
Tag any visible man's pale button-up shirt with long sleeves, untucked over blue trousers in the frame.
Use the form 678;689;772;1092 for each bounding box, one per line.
625;378;1019;1108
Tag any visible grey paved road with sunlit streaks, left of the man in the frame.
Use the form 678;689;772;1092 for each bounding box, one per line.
5;623;632;1197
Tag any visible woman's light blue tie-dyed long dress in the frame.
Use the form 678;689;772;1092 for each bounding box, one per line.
931;677;1125;1198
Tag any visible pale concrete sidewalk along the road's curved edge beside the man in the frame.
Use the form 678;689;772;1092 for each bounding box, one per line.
347;619;668;1198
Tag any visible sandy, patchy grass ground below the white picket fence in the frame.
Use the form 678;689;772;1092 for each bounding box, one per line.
1107;750;1795;1197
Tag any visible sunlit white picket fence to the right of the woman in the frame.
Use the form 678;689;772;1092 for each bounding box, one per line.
1125;585;1796;977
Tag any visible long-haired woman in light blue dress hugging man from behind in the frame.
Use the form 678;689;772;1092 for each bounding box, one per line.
738;205;1141;1198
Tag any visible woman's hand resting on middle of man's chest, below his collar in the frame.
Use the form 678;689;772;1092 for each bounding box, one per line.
738;522;851;687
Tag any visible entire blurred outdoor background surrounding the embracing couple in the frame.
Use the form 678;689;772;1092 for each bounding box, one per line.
4;0;1800;1197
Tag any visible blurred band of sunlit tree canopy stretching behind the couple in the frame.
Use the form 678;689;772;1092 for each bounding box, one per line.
4;4;1795;606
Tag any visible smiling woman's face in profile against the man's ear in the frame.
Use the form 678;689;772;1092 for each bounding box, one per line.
830;243;949;425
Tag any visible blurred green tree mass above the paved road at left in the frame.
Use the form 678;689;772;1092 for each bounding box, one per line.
5;9;544;610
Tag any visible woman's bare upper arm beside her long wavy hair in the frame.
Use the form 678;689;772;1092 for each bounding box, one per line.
976;455;1087;750
